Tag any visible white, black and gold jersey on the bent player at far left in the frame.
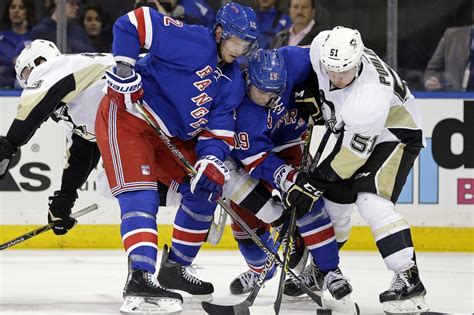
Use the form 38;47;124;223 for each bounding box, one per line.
8;53;115;146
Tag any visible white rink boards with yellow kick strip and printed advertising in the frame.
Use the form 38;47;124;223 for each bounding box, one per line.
0;93;474;252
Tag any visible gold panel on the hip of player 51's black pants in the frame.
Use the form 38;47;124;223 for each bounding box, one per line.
375;143;406;200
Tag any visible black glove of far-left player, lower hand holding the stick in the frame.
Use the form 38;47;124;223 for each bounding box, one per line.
48;191;77;235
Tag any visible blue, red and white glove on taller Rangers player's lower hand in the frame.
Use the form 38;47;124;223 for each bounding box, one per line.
191;155;230;201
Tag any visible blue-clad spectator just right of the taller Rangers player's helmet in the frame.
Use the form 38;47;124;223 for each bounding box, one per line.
255;0;291;49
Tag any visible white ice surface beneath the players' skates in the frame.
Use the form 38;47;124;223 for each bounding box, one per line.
0;249;474;315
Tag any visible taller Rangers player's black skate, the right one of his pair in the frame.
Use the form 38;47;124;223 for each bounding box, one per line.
158;245;214;300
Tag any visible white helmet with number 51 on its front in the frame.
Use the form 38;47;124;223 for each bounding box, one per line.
320;26;364;72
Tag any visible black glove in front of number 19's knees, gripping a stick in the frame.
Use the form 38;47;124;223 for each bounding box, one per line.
283;172;323;218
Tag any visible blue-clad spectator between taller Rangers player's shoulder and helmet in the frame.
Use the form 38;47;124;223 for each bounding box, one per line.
158;0;215;27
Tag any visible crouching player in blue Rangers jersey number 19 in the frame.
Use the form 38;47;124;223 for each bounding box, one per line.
226;47;352;299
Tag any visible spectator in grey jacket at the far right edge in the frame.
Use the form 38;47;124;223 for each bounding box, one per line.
424;25;474;91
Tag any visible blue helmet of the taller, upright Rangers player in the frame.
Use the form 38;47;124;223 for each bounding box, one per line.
214;2;259;44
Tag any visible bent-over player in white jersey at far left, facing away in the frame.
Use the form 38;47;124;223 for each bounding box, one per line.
0;39;115;235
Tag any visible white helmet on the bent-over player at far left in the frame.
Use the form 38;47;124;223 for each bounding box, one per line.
15;39;61;87
